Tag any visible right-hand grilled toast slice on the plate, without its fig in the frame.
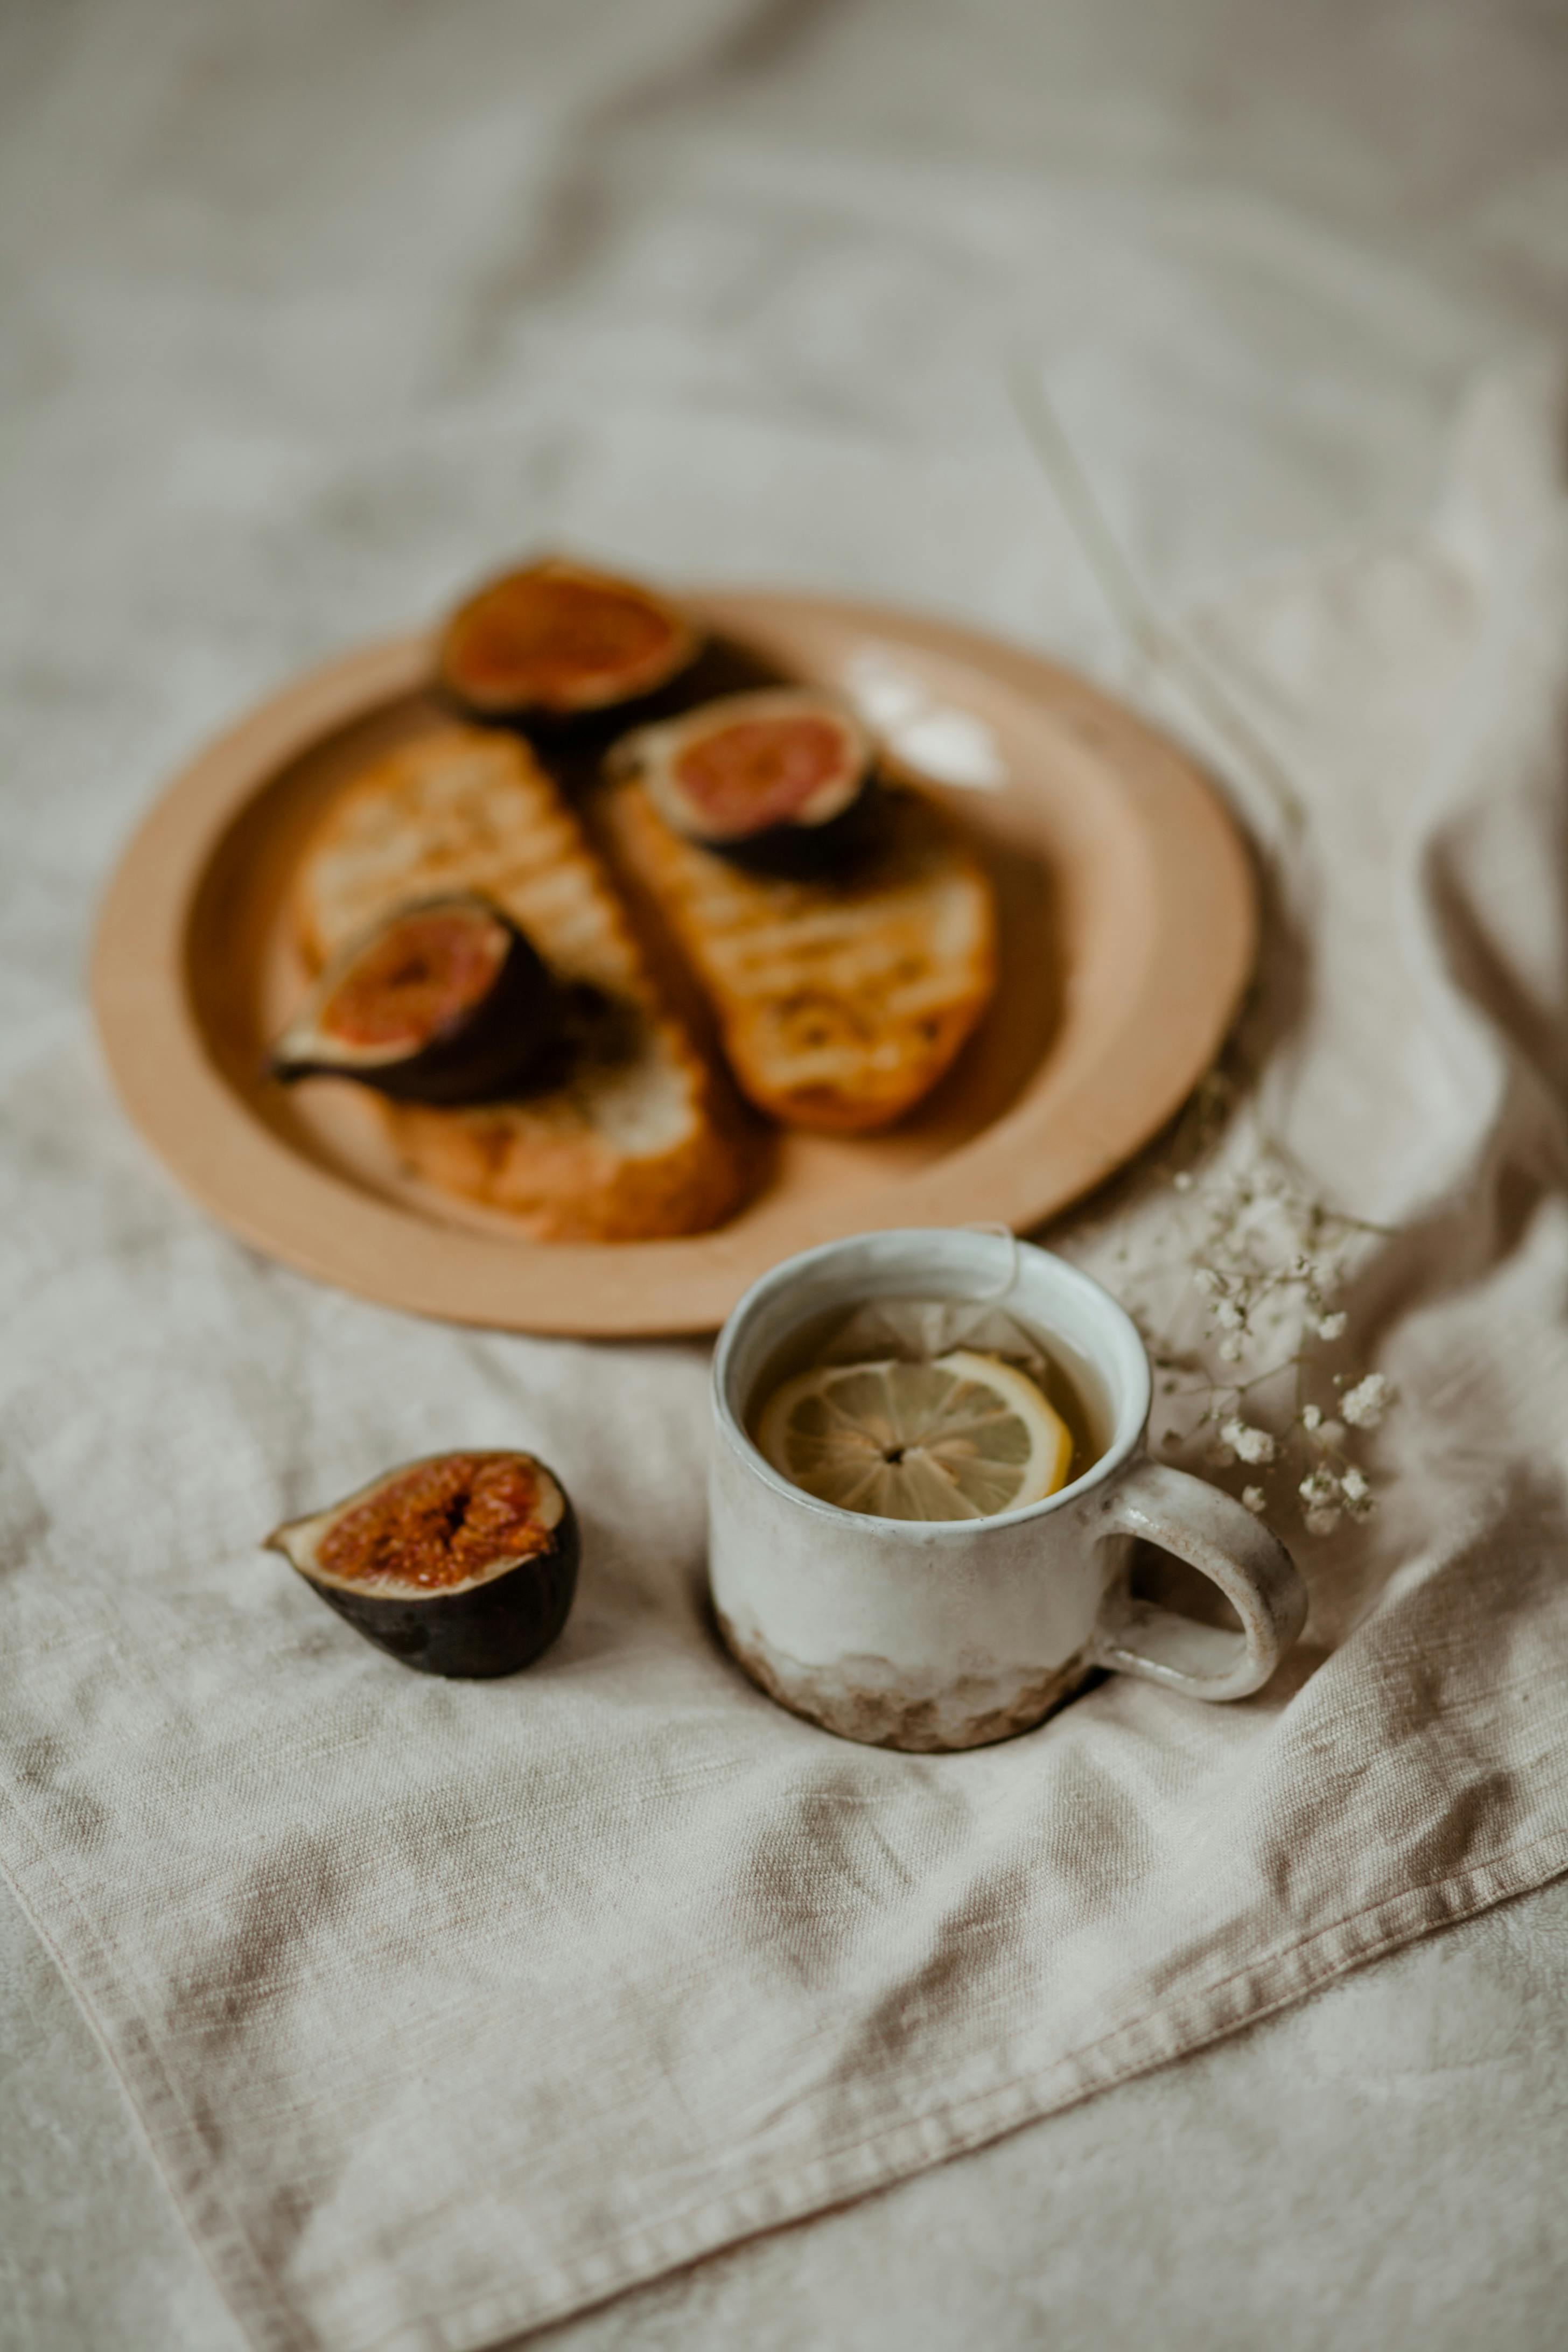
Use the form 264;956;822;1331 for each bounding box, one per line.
604;781;997;1133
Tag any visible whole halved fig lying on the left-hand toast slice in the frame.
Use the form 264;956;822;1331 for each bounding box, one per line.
270;891;562;1103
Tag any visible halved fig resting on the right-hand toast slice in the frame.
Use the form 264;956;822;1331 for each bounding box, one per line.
609;687;872;873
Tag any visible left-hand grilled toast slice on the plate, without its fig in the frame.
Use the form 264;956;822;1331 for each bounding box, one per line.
291;727;745;1242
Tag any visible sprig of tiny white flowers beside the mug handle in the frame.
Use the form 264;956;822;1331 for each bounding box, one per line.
1133;1070;1394;1536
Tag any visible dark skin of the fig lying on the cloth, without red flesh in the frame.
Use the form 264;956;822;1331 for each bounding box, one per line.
265;1453;583;1682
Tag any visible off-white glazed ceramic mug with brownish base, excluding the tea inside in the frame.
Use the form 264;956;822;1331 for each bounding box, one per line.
708;1228;1307;1750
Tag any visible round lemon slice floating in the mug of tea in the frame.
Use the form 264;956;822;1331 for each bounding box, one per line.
757;1348;1072;1520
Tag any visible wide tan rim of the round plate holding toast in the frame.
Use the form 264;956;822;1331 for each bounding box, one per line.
89;588;1260;1338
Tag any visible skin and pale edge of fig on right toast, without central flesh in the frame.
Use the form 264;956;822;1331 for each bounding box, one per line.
604;687;881;882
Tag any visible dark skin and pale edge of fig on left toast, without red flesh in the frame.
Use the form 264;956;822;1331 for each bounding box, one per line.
268;891;564;1108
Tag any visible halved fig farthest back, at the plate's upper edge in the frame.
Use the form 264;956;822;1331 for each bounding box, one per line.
437;557;701;720
